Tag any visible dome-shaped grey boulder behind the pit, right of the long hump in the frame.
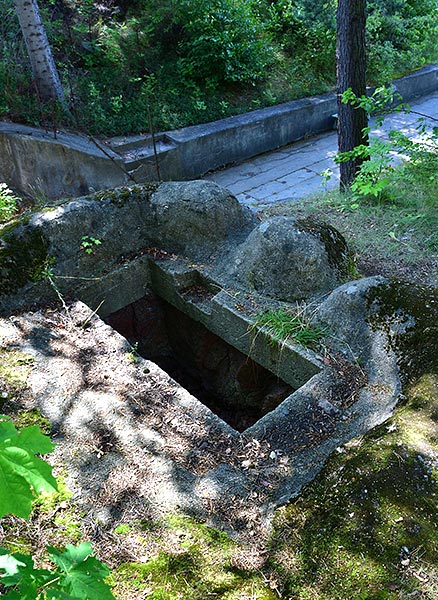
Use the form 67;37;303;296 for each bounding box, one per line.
228;217;349;301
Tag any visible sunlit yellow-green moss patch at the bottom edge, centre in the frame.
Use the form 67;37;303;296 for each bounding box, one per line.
111;516;278;600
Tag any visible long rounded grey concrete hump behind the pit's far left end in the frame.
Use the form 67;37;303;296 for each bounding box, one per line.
0;181;256;311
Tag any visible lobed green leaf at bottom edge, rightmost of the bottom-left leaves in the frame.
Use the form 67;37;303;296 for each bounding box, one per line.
47;542;114;600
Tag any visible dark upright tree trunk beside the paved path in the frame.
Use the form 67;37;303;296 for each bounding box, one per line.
336;0;368;190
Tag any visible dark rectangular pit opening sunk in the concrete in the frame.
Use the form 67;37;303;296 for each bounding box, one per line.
105;293;294;432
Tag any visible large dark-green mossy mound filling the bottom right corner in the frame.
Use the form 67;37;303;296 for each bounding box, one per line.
269;375;438;600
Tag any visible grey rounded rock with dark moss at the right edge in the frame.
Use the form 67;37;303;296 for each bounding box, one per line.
314;277;438;377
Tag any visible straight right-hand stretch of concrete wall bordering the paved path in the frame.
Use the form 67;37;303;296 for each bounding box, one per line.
162;65;438;179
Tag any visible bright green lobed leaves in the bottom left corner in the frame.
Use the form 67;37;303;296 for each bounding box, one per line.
0;416;114;600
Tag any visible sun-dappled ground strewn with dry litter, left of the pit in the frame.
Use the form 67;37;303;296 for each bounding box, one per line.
0;303;366;539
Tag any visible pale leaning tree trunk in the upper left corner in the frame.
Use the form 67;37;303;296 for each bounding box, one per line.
14;0;65;106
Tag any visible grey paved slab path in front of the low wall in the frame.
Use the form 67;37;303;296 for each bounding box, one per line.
204;91;438;210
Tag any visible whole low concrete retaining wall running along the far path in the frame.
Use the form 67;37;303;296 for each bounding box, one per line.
0;65;438;199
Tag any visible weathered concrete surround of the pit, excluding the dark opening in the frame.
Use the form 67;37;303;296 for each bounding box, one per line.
0;182;437;519
